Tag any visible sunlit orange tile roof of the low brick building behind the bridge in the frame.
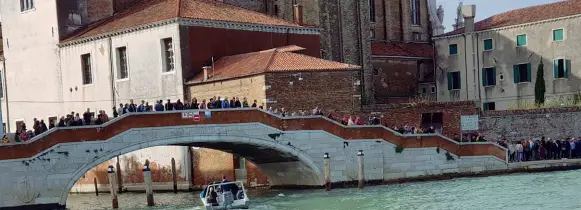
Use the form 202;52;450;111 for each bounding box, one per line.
187;46;361;83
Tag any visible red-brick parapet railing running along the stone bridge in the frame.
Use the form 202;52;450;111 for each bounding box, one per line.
0;108;508;162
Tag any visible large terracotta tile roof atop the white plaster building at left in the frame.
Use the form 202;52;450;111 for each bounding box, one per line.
64;0;301;42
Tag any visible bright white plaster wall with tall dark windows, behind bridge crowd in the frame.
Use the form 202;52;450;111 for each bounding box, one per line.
59;23;184;113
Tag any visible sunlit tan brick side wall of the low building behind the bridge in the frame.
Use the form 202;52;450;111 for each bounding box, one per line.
188;74;266;106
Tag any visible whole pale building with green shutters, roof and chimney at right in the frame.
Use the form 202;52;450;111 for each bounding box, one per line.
434;0;581;110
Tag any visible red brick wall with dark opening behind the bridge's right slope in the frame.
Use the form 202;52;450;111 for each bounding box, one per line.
364;101;477;137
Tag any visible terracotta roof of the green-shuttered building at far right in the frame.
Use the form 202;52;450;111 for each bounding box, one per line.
439;0;581;37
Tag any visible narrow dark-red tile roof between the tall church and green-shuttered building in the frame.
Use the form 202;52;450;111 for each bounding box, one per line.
371;42;434;58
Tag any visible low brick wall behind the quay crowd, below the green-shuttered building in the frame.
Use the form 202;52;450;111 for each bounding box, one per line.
480;107;581;140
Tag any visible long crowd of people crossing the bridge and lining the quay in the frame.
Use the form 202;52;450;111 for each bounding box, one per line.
7;96;581;162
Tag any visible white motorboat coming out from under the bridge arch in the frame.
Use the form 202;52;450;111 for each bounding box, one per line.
200;181;249;210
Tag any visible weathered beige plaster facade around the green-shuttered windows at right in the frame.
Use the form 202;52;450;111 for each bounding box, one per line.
434;11;581;110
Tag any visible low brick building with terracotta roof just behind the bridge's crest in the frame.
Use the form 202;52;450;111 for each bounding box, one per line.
186;46;360;113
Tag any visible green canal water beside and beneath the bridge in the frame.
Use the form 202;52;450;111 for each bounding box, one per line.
67;170;581;210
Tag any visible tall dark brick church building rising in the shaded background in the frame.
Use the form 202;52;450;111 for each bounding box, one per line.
223;0;444;104
